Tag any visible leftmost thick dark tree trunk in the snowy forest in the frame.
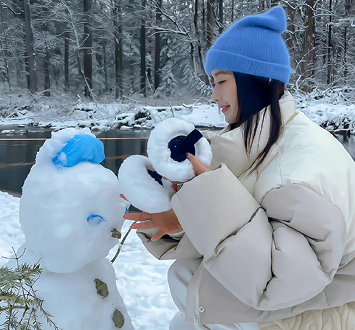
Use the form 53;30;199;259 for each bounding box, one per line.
23;0;38;93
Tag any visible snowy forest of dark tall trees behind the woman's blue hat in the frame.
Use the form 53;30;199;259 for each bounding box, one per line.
0;0;355;101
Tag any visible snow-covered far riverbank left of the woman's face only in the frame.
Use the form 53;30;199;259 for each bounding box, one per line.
0;91;225;133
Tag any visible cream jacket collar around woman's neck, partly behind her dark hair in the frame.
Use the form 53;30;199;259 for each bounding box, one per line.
207;91;297;177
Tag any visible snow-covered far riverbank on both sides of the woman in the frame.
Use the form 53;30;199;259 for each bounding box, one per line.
0;90;355;134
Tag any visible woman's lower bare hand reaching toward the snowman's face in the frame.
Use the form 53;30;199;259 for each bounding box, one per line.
123;209;183;241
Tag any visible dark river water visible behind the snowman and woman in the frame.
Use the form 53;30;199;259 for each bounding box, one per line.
0;129;355;193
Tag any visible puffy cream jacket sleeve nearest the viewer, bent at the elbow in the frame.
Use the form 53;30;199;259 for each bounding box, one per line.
172;165;345;311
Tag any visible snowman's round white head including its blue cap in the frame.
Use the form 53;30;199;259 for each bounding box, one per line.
20;128;127;273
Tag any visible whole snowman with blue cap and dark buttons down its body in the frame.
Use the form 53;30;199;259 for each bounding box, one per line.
1;128;133;330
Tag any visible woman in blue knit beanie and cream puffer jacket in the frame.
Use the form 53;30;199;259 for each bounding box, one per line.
125;7;355;330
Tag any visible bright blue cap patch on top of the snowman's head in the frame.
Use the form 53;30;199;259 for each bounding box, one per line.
52;134;105;167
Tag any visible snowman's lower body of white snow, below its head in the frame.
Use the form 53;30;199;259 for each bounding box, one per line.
0;244;134;330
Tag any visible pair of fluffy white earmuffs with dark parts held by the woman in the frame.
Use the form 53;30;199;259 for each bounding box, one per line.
118;118;212;213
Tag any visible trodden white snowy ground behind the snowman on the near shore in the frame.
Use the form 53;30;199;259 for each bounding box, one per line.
0;192;177;330
